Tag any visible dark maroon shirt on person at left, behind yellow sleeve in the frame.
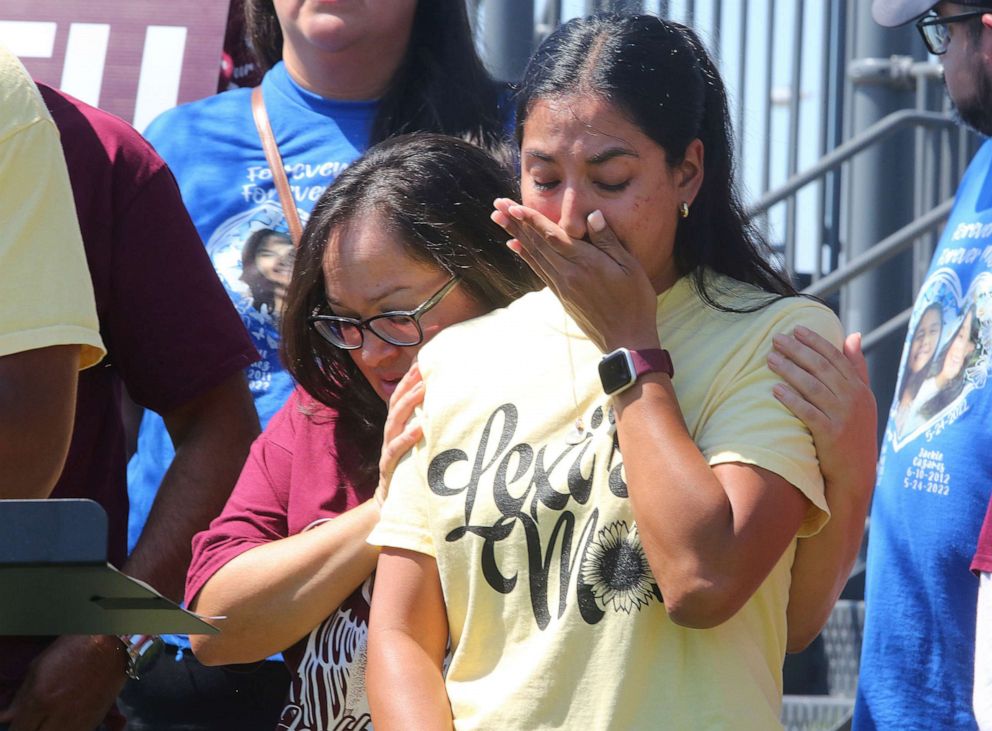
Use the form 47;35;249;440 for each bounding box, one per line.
0;84;258;708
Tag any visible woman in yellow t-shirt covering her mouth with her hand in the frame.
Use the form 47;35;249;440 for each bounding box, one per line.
367;15;874;731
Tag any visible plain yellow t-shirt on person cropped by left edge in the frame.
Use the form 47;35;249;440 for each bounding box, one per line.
0;46;104;369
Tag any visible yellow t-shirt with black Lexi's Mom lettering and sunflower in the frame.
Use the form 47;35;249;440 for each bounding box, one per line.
369;276;841;730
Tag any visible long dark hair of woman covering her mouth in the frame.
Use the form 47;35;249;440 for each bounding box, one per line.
517;13;797;312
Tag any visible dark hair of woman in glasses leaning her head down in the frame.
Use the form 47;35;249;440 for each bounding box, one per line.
282;133;541;478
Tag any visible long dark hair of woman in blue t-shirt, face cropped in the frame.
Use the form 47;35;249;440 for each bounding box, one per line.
245;0;507;152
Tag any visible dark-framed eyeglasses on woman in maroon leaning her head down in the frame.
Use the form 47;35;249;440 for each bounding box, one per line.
307;275;461;350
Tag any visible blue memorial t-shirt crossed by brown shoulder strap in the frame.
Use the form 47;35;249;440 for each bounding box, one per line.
128;62;376;644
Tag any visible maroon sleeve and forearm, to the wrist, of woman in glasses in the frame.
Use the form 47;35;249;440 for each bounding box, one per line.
187;390;378;665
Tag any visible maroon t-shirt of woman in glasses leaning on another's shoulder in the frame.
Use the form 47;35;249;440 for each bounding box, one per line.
186;387;375;729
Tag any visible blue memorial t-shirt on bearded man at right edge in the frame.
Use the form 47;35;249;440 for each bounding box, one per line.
854;141;992;731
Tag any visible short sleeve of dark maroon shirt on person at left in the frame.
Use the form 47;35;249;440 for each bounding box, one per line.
107;159;258;413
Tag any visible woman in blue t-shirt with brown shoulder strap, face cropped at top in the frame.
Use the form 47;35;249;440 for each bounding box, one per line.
123;0;507;731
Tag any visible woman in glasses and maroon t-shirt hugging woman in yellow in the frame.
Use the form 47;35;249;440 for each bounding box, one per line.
187;135;539;731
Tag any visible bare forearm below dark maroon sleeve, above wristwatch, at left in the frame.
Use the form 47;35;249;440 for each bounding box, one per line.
123;373;259;601
